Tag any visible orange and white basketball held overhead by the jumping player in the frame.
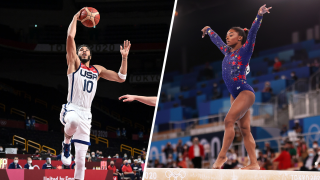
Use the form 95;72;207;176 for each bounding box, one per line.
79;7;100;27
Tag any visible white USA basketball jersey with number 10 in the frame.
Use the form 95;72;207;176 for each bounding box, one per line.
67;63;99;108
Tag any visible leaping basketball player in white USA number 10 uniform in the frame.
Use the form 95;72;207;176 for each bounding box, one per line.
60;10;131;180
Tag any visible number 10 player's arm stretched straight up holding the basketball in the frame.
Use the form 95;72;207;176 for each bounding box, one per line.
66;9;82;66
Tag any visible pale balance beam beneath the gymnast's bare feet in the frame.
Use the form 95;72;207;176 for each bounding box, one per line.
143;168;320;180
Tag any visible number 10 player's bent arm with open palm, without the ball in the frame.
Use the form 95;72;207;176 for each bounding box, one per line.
94;40;131;83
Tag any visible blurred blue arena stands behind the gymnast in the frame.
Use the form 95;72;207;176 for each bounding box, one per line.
148;0;320;170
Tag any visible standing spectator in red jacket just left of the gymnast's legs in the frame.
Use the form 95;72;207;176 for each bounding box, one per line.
189;137;204;168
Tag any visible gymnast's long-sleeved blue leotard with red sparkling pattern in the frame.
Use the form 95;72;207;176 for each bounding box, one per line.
207;15;262;99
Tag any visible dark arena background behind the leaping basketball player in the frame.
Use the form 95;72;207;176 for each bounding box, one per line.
0;0;174;178
